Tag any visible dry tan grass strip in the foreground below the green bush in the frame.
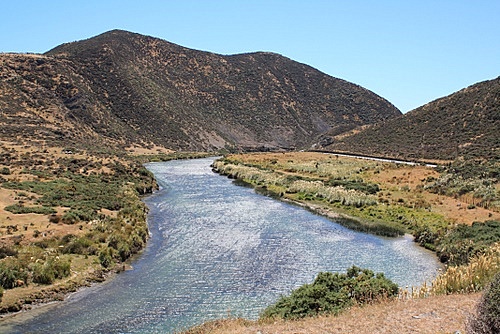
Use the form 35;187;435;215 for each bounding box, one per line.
186;293;480;334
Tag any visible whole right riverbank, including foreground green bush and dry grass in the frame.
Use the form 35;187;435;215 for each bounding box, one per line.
182;152;500;334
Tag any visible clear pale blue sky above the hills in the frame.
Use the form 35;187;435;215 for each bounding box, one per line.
0;0;500;112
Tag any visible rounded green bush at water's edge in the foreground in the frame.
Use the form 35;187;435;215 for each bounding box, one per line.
262;266;398;319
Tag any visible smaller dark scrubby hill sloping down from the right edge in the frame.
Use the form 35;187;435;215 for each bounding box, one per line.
322;77;500;160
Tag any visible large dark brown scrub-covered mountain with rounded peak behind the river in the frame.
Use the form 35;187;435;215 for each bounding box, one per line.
0;30;401;151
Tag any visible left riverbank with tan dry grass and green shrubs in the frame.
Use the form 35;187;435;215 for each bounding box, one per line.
0;143;206;312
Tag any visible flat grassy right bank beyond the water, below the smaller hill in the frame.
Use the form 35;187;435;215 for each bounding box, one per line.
213;152;500;293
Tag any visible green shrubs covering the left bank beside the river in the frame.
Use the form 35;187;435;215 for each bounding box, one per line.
0;155;156;289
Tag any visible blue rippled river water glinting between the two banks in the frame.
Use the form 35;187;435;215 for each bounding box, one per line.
0;159;439;333
